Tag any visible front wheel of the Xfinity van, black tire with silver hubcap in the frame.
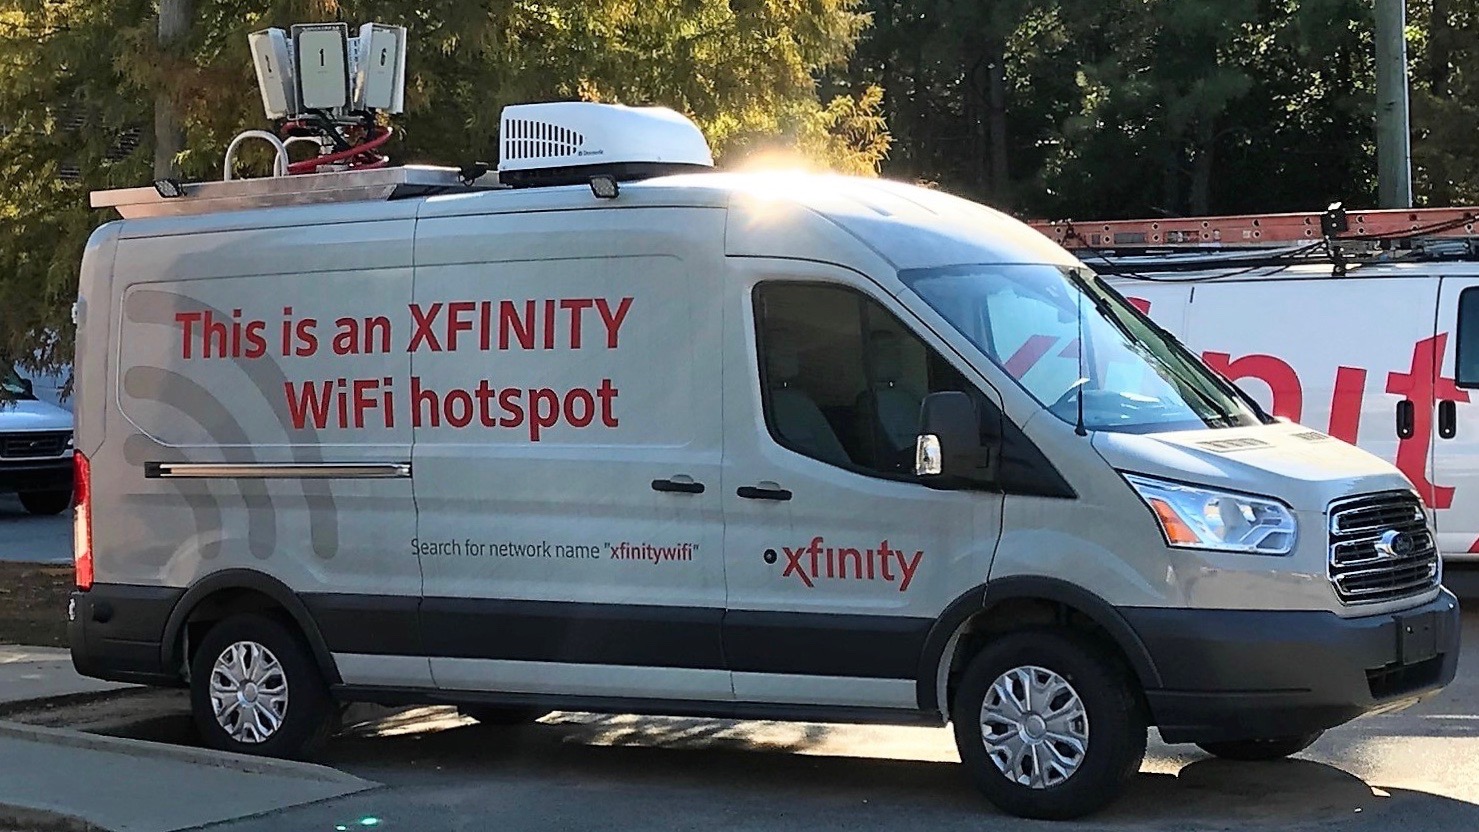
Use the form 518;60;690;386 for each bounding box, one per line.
951;628;1146;820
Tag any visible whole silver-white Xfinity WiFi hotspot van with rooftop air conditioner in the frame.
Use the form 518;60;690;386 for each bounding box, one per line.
70;105;1458;817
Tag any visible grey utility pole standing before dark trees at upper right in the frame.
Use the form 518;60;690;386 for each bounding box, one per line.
1375;0;1412;208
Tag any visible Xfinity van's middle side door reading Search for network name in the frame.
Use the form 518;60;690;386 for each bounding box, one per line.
408;204;731;700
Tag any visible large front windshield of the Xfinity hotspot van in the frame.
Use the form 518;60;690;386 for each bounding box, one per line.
899;266;1260;433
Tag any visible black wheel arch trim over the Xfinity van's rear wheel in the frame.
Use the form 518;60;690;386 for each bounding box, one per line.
160;569;342;684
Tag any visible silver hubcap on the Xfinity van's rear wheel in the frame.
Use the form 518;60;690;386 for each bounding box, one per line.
210;641;287;743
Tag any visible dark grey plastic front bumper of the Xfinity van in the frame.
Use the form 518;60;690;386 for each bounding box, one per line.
1120;590;1461;742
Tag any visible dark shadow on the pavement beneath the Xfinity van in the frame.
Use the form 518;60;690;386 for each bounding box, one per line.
322;709;1479;832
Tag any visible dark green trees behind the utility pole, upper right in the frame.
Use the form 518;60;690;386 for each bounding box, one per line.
847;0;1479;219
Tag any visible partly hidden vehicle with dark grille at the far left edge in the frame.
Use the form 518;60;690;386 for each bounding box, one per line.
0;359;72;514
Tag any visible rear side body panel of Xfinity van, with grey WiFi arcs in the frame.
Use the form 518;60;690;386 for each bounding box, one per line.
107;211;430;686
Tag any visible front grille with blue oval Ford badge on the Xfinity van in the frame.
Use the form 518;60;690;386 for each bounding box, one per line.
1330;491;1439;604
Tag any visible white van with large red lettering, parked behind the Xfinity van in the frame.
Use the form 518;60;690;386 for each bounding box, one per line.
1096;257;1479;562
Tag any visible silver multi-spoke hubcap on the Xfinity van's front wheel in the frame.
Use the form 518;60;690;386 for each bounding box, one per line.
981;666;1089;789
